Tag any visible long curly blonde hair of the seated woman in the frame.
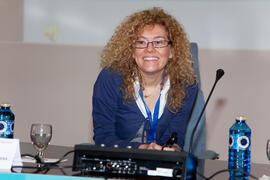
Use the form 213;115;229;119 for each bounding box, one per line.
101;7;196;113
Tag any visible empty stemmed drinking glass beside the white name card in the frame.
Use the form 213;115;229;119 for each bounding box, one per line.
30;124;52;159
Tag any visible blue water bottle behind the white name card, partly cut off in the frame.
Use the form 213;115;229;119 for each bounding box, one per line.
0;104;15;138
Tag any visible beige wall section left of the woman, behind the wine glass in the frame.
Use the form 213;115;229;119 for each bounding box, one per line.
0;43;101;145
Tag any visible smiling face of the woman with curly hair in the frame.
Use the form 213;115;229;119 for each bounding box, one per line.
133;24;172;76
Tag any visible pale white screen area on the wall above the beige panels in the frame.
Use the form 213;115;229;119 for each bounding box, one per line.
24;0;270;49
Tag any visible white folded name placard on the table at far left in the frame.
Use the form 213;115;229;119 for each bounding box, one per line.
0;138;22;172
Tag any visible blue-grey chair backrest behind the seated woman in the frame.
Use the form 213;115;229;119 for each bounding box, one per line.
184;43;206;156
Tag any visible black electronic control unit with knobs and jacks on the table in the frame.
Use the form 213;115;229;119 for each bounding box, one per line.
72;144;188;179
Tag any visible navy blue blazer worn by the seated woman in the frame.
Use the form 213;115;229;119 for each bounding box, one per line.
92;69;198;148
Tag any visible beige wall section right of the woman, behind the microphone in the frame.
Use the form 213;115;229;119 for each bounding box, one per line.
199;49;270;163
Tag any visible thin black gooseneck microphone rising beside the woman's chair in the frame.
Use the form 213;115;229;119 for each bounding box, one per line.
188;69;224;153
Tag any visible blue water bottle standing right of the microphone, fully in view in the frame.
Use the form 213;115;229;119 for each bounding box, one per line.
228;116;251;180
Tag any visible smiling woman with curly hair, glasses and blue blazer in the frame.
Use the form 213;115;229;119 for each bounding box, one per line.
93;8;197;151
